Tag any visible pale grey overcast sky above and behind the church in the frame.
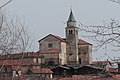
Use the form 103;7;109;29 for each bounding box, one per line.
0;0;120;59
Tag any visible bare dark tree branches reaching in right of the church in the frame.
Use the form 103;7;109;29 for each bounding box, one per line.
80;19;120;50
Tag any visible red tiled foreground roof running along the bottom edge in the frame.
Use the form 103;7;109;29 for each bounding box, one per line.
0;74;120;80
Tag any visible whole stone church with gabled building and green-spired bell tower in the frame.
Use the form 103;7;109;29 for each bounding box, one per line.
38;10;92;65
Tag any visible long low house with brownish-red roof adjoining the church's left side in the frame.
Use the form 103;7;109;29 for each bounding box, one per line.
0;52;43;64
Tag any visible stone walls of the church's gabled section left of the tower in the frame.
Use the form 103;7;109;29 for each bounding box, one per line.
39;35;66;65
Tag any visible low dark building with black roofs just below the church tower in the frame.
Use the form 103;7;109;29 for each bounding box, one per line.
52;65;104;76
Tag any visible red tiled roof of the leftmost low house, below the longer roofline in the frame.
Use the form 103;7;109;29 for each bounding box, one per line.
0;60;39;66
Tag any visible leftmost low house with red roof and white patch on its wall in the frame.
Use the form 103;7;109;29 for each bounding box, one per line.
0;60;39;77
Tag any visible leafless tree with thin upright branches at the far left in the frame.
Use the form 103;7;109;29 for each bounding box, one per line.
0;11;30;53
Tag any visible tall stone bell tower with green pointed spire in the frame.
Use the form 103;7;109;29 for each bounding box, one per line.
65;10;79;64
